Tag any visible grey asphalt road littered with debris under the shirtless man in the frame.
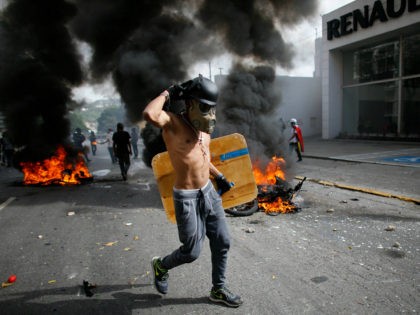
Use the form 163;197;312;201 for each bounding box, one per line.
0;146;420;314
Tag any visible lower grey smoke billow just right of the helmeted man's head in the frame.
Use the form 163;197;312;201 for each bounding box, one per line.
218;64;283;162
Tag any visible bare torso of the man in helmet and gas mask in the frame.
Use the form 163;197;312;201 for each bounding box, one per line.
162;113;210;189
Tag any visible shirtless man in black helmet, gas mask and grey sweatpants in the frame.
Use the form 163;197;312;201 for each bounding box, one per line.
143;75;242;307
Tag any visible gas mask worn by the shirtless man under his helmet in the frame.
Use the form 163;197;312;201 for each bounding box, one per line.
187;100;216;134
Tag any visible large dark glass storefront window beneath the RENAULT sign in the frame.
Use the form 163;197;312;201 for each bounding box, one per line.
341;35;420;138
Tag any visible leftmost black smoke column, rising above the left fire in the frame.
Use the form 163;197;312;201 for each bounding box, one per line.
0;0;83;160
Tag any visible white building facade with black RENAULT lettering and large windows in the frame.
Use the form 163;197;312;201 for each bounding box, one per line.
321;0;420;139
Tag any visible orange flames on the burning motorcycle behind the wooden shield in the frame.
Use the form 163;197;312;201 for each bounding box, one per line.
252;156;296;213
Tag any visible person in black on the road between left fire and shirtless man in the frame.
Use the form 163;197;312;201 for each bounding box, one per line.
112;123;132;180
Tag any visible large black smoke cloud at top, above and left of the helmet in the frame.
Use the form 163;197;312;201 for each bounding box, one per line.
72;0;221;122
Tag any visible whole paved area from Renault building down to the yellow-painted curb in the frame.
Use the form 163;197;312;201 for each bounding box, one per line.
296;137;420;204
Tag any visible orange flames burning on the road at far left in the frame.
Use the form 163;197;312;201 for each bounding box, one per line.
20;146;92;186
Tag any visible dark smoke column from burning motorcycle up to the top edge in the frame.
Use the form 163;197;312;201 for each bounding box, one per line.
198;0;317;167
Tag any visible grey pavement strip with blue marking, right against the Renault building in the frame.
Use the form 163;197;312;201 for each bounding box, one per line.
303;137;420;167
